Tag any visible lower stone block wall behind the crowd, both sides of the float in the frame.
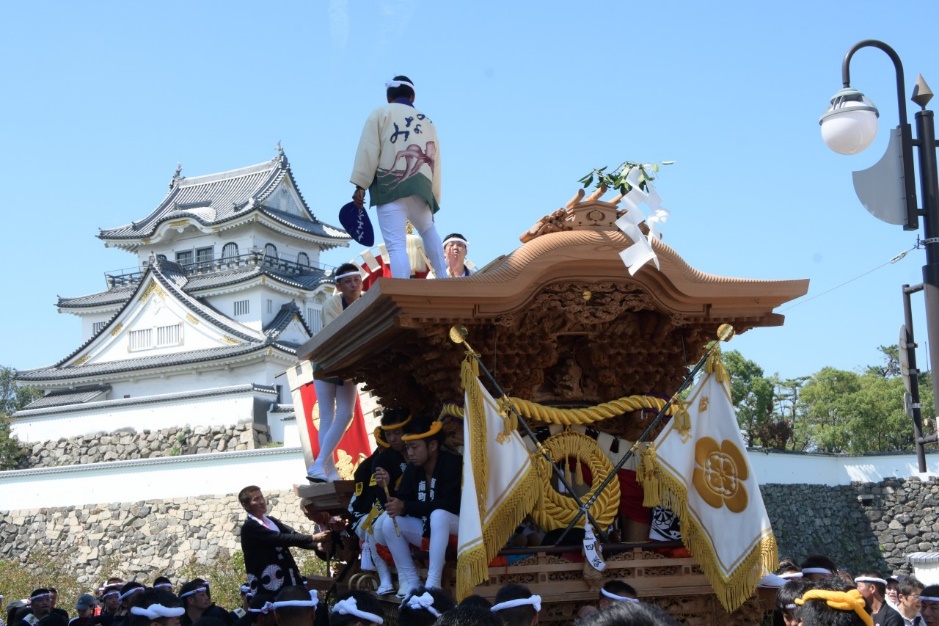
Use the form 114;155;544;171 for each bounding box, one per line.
0;479;939;583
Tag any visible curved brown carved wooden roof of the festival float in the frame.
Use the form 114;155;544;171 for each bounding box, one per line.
298;194;808;411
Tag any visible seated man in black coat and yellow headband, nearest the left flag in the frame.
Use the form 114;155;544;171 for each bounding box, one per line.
375;416;463;595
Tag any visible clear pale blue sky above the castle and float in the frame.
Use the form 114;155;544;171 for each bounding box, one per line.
0;0;939;386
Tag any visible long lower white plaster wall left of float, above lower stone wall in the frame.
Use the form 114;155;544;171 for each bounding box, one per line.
0;447;306;511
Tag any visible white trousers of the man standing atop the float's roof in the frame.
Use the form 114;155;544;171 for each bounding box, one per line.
378;196;447;278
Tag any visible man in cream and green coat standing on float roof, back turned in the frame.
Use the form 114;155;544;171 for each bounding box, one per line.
350;76;447;278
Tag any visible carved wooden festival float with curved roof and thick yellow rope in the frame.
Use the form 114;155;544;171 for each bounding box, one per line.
298;188;808;625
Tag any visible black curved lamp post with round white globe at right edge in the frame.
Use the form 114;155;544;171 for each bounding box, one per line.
819;39;939;471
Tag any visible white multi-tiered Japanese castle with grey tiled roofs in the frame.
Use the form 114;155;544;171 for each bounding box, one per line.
13;146;349;442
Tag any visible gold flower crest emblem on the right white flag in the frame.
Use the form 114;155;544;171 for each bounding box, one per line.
692;437;749;513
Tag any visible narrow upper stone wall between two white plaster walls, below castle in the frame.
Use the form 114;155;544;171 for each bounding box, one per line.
19;421;270;469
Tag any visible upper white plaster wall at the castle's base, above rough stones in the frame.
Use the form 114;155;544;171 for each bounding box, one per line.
11;391;275;443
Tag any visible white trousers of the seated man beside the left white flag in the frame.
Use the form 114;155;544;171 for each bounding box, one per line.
382;509;460;589
